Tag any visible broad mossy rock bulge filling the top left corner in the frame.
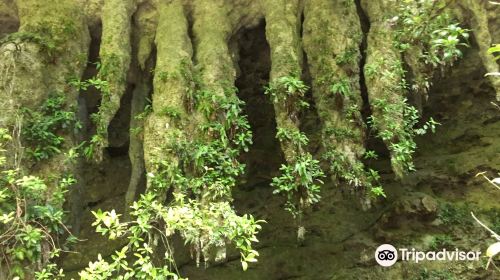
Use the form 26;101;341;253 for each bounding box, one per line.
0;1;89;125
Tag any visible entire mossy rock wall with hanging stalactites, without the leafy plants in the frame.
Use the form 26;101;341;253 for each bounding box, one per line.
0;0;500;279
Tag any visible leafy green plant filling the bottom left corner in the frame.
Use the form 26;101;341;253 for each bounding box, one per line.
0;128;76;279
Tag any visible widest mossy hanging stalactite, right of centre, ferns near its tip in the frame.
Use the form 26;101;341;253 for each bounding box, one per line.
304;0;371;190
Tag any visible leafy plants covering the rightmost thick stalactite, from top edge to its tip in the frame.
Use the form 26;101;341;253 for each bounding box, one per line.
365;0;462;177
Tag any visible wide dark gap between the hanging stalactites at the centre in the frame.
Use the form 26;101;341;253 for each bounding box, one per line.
233;21;284;187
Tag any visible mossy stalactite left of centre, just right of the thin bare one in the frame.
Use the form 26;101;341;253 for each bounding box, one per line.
144;1;193;187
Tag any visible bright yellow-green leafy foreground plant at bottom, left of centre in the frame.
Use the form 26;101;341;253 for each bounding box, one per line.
79;192;262;280
